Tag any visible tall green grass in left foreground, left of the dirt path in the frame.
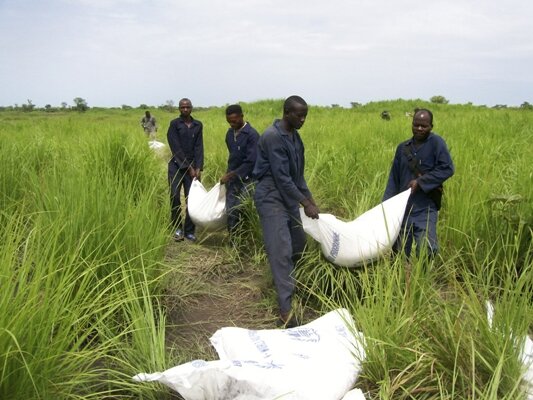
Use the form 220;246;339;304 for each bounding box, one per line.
0;116;169;399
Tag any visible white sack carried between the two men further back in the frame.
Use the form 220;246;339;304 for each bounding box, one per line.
187;179;227;231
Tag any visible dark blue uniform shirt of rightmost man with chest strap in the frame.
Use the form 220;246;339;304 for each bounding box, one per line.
383;132;455;214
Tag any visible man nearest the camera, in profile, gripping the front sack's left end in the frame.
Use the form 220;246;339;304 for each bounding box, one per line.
253;96;319;327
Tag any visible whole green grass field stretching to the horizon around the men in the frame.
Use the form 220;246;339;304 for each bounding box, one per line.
0;100;533;400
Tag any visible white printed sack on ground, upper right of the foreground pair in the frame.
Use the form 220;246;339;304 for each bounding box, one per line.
210;309;364;400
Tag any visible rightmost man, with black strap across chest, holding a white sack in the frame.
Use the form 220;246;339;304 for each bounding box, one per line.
383;109;455;257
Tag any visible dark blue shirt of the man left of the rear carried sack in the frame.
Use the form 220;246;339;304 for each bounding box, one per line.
167;117;204;170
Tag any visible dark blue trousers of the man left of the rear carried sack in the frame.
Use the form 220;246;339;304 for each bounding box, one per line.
168;160;195;235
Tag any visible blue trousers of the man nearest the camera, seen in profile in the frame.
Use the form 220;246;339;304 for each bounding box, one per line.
254;183;306;314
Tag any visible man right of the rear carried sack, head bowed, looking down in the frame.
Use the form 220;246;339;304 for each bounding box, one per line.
220;104;259;240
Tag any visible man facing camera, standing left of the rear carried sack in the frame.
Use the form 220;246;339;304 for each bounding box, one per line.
167;98;204;242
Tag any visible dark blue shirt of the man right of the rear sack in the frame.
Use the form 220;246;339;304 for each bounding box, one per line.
226;123;259;181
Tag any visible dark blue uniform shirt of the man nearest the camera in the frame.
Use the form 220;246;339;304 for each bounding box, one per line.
253;119;311;209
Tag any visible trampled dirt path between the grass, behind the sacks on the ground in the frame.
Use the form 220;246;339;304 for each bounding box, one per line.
165;233;277;361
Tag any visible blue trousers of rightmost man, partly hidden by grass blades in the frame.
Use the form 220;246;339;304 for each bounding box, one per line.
392;207;439;257
